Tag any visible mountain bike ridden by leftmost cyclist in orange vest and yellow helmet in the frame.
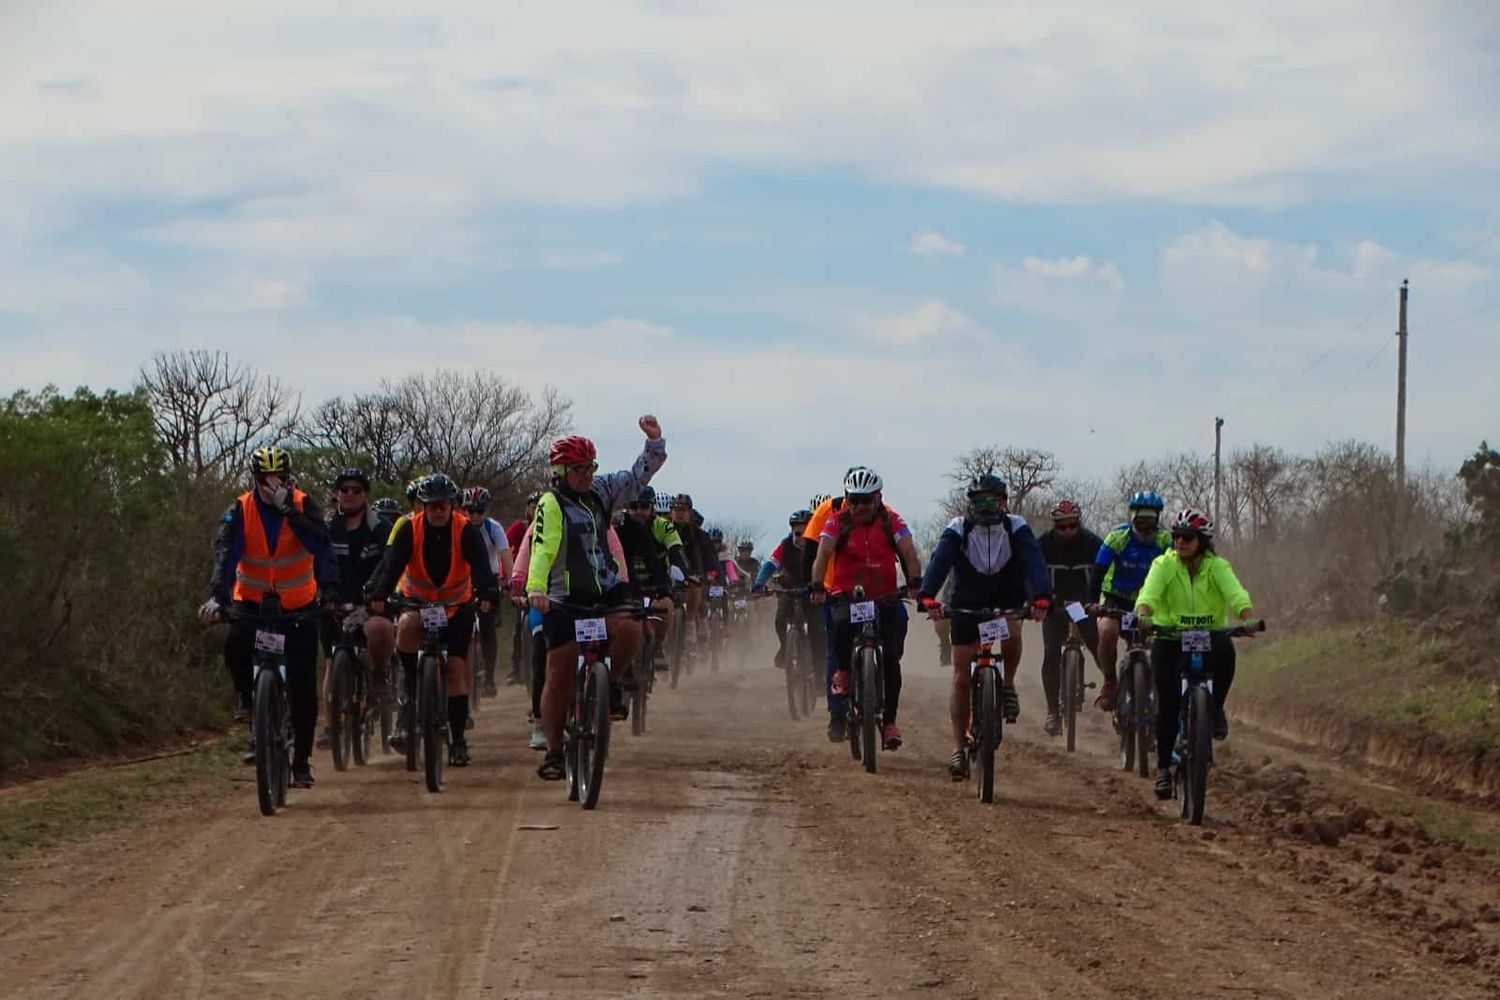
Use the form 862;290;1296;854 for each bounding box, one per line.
224;594;323;816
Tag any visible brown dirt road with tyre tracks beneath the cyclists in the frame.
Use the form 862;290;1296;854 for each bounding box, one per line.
0;627;1500;1000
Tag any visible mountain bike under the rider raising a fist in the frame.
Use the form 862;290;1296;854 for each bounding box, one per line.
552;600;644;810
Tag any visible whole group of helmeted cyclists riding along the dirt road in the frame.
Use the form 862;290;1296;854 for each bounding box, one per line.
200;415;1254;798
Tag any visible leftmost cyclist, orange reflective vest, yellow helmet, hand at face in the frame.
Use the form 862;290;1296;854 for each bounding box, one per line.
198;447;339;789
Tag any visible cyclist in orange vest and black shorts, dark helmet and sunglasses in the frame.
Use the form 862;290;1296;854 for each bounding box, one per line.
365;472;500;768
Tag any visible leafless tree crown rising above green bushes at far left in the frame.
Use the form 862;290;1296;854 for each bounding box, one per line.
140;351;302;475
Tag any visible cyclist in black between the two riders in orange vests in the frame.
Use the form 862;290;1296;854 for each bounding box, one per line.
318;468;396;747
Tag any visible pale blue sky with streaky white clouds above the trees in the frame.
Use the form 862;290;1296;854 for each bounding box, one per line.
0;0;1500;539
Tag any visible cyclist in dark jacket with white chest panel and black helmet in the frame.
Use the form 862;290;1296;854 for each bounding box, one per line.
918;472;1052;780
